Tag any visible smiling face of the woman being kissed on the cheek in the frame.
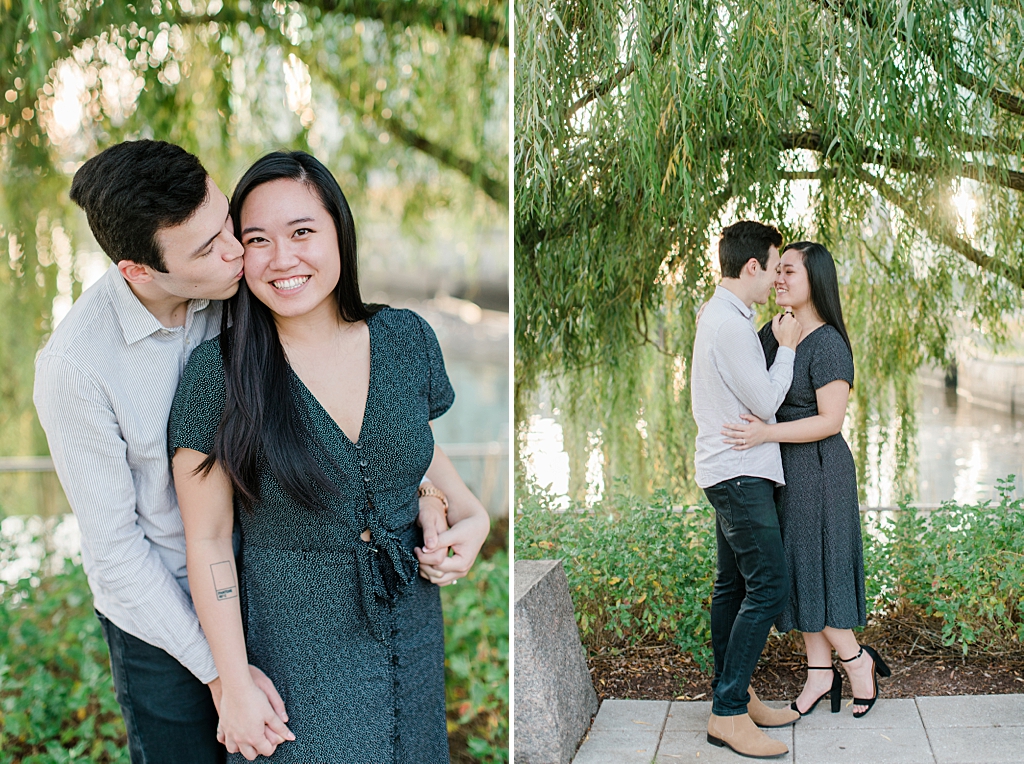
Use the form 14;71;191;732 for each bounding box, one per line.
241;179;341;317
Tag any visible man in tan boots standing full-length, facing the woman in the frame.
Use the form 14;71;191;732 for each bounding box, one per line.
691;220;801;758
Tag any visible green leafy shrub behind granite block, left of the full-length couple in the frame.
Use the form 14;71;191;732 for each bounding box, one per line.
515;491;715;667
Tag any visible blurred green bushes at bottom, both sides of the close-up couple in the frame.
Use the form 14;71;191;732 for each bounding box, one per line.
0;524;509;764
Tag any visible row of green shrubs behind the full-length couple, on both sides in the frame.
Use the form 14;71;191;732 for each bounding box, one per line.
515;477;1024;667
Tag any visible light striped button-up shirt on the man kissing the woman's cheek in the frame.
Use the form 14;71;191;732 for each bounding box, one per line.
33;265;221;682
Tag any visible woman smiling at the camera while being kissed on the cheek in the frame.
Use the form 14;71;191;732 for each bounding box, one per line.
169;152;489;764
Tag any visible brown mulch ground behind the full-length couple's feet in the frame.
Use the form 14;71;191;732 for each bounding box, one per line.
588;618;1024;701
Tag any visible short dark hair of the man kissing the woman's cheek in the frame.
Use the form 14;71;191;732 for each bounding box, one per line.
71;140;208;273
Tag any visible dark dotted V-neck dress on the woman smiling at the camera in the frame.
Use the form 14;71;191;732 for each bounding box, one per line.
168;308;455;764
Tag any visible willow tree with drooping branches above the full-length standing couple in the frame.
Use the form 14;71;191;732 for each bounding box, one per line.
514;0;1024;499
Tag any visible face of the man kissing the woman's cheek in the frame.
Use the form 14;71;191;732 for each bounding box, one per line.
148;177;243;300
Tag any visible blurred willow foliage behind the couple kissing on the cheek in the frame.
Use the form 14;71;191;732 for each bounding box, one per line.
0;0;509;454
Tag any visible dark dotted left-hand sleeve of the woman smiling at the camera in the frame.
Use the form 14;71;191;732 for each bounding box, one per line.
167;338;224;457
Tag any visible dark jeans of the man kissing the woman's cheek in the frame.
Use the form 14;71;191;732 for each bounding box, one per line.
96;611;227;764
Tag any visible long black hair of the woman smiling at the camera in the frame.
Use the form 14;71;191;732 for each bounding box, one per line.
201;152;382;510
